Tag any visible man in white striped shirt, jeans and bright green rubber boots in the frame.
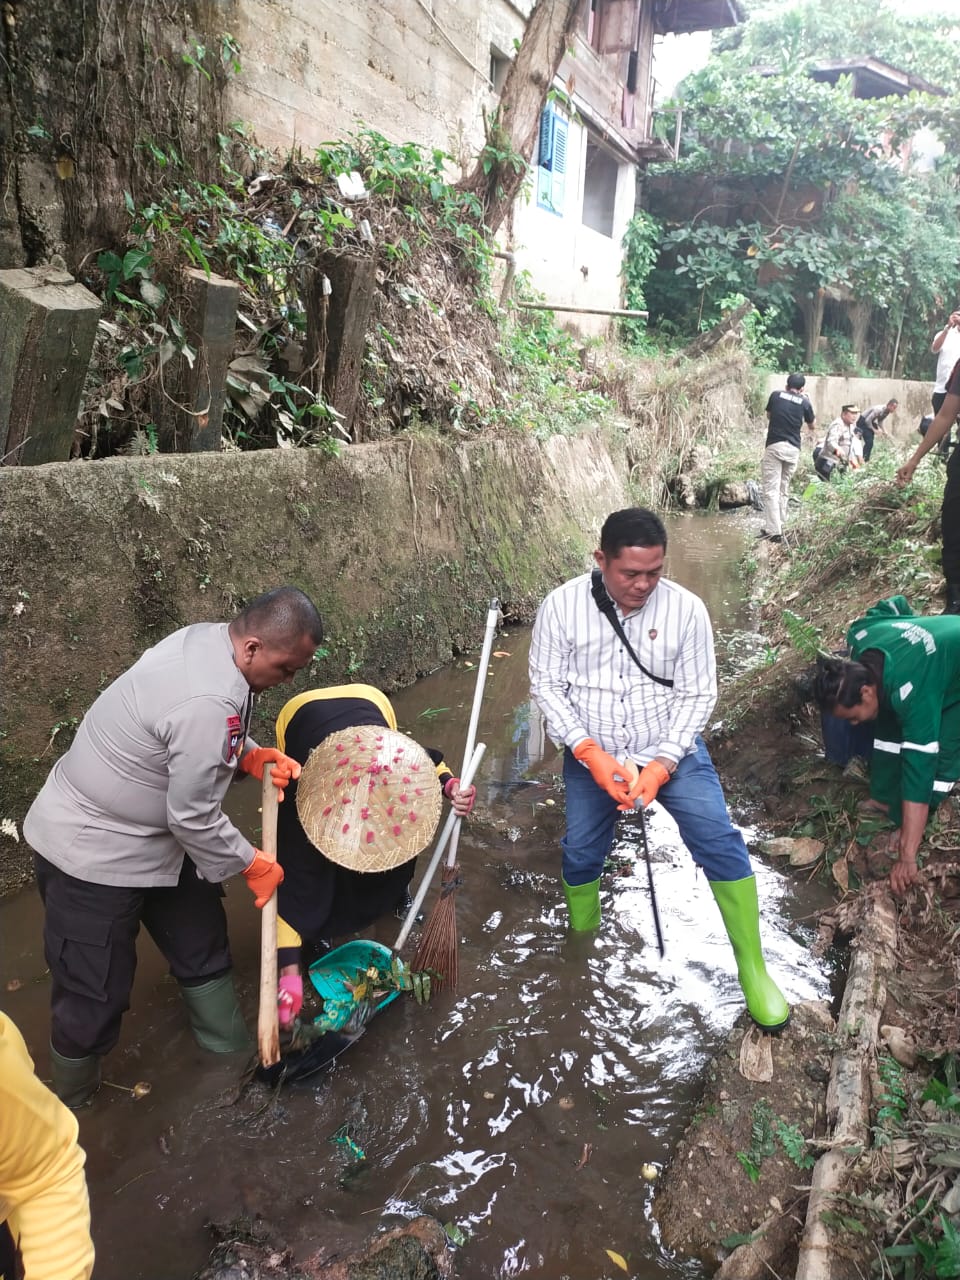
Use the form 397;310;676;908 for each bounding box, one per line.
530;507;790;1029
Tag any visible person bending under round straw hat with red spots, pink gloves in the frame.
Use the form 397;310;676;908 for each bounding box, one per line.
276;685;476;1027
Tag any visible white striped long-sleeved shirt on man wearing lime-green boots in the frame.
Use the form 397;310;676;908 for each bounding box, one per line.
530;573;717;764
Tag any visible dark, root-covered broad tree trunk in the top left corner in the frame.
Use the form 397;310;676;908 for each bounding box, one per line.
0;0;227;271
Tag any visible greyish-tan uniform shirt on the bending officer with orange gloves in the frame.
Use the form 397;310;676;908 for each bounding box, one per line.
23;622;255;886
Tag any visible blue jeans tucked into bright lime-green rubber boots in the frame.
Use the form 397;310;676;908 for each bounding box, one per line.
561;737;753;884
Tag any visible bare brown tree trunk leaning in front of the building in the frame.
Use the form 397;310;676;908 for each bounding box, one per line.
460;0;580;232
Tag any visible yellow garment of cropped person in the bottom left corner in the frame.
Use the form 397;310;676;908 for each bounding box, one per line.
0;1014;93;1280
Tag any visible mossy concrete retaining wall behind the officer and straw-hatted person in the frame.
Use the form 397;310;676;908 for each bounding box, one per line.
0;433;627;891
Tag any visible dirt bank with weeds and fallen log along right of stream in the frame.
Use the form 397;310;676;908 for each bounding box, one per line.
657;476;960;1280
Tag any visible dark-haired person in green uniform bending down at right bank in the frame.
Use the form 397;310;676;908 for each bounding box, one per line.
814;595;960;893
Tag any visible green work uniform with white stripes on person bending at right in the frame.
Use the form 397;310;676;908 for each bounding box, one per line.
846;595;960;826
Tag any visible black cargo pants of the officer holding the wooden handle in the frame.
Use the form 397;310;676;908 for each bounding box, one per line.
35;854;230;1057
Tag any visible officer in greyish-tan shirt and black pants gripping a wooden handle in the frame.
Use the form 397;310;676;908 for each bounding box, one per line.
23;586;323;1106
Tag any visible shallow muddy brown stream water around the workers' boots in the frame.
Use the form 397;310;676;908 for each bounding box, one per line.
0;516;829;1280
